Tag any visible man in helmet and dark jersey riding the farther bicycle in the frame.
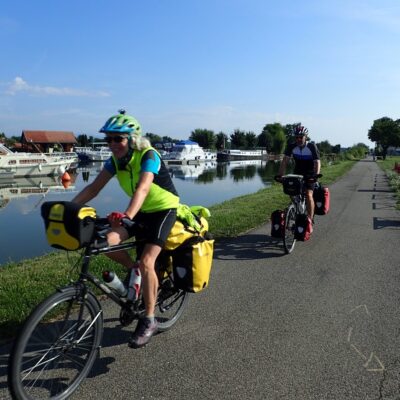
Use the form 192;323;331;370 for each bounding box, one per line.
278;125;321;222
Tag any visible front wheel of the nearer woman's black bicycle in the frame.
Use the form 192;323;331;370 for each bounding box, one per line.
8;286;103;400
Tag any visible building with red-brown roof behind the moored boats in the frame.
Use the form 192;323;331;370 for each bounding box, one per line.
21;131;77;153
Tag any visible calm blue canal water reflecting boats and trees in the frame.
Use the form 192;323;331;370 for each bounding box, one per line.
0;160;279;265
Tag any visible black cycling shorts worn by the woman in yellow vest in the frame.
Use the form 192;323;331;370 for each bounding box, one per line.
127;208;176;247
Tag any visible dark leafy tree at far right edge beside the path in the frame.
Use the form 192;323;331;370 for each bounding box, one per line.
368;117;400;159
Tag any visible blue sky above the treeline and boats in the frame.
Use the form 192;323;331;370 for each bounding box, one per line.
0;0;400;147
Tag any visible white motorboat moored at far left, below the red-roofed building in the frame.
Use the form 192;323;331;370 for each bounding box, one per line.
0;143;78;177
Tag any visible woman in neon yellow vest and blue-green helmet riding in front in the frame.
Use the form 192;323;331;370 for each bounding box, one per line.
72;110;179;348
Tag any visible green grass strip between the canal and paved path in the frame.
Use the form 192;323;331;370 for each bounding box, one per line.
0;161;355;338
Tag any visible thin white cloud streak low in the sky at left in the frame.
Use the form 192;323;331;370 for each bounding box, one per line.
6;76;110;97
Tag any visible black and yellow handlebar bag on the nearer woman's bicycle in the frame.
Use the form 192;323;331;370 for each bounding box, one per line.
41;201;96;250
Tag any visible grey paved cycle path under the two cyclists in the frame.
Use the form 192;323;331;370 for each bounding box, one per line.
0;160;400;400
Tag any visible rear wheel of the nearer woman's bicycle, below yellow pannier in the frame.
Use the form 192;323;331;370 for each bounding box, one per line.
155;272;189;332
